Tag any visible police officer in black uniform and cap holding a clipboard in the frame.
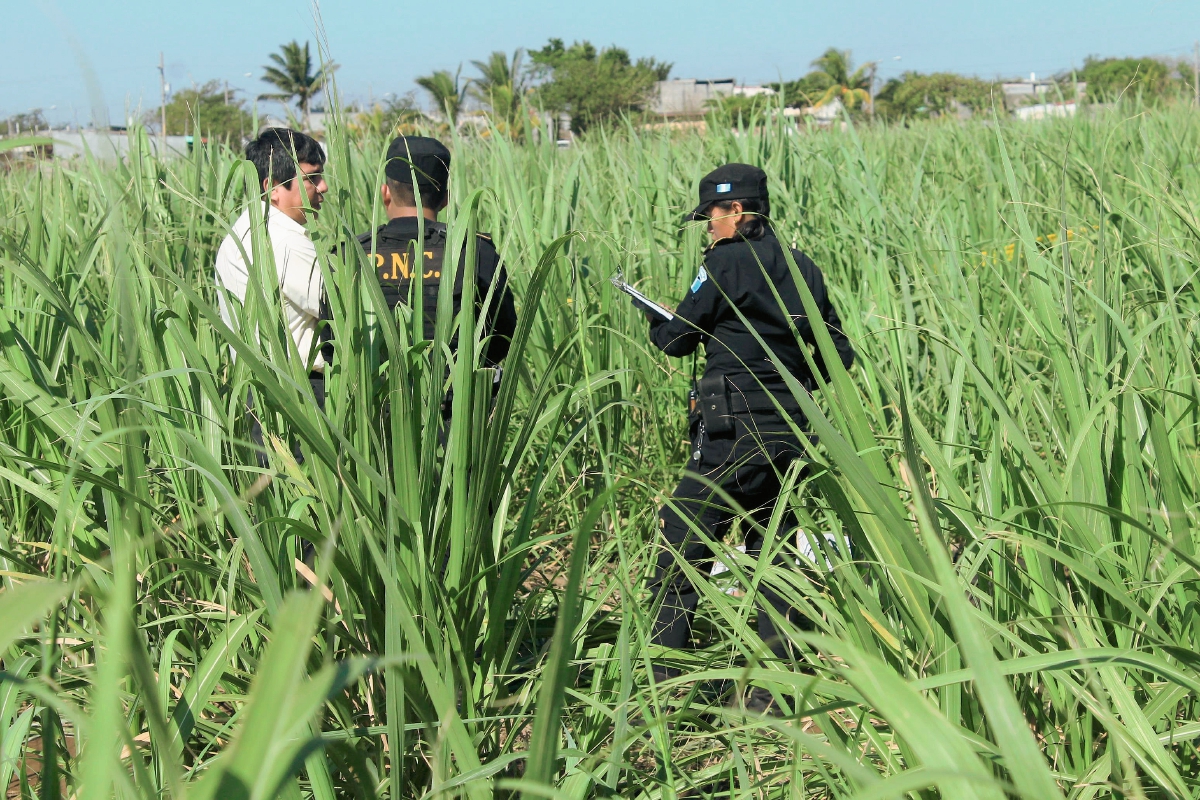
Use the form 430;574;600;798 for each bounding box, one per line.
647;164;854;703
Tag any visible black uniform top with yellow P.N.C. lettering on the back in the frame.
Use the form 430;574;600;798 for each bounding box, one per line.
358;217;517;366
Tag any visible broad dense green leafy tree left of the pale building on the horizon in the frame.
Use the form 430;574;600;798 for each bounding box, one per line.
529;38;671;131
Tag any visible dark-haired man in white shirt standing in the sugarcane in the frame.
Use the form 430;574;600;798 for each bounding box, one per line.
216;128;329;462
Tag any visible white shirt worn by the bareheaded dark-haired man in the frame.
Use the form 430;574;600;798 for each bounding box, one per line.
216;206;325;371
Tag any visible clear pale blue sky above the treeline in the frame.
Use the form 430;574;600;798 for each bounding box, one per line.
7;0;1200;122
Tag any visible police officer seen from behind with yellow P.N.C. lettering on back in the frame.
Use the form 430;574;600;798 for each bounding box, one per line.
359;137;517;367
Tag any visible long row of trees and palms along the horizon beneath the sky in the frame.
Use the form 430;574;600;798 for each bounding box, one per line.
7;38;1195;140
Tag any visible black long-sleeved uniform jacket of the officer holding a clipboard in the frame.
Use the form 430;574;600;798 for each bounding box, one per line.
650;228;854;392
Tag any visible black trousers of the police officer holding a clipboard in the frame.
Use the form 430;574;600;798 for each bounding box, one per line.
650;413;803;657
